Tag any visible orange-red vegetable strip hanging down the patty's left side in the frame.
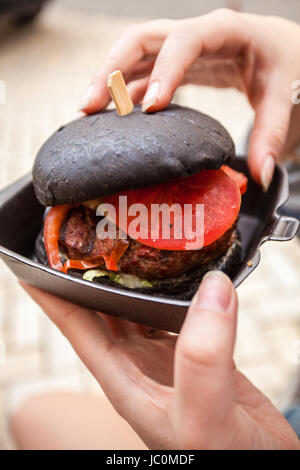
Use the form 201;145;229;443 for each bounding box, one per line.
44;204;72;272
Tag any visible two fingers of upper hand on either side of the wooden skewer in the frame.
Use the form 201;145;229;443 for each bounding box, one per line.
80;9;247;113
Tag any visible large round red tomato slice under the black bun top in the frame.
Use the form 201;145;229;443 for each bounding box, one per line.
104;169;241;250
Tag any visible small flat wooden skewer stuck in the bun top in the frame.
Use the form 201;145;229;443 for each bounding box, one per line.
107;70;133;116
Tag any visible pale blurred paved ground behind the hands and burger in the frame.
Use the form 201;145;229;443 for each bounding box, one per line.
0;0;300;448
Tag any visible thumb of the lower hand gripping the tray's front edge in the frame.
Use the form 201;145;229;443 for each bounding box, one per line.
175;271;237;442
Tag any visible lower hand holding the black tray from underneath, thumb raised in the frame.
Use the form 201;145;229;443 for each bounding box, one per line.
19;271;299;449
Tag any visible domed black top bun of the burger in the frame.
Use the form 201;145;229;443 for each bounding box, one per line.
33;105;234;206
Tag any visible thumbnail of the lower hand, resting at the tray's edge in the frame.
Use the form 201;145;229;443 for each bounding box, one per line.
192;271;234;313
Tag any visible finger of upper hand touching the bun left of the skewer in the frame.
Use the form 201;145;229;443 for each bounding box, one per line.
79;20;173;114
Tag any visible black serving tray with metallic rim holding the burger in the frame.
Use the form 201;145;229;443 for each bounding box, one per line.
0;157;299;332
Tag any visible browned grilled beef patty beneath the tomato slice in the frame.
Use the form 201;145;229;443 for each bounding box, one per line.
60;204;237;280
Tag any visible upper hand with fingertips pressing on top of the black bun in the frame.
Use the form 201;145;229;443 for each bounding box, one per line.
80;9;300;190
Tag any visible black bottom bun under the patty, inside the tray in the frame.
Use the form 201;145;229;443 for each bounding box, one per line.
35;230;242;300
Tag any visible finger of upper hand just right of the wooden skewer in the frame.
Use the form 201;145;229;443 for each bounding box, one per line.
143;9;247;111
